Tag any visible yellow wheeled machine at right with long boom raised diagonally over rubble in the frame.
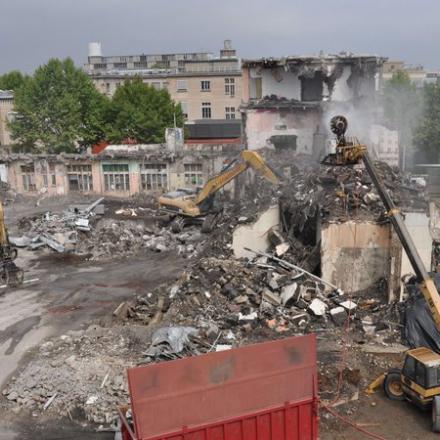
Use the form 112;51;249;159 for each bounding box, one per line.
323;116;440;432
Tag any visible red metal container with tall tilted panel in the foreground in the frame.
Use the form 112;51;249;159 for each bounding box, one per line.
119;335;318;440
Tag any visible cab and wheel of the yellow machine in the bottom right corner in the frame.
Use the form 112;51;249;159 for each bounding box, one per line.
383;347;440;432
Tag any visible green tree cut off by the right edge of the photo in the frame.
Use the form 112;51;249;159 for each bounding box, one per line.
414;80;440;162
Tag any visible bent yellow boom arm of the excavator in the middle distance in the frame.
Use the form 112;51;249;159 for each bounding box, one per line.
195;150;278;205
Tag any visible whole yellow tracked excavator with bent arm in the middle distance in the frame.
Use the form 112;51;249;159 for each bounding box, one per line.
158;150;279;232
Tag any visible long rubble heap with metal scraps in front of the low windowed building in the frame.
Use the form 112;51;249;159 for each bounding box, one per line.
10;199;206;261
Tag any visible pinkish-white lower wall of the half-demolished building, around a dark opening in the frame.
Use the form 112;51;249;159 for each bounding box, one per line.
245;109;321;154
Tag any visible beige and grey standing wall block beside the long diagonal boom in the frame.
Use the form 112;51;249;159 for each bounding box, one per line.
321;221;391;292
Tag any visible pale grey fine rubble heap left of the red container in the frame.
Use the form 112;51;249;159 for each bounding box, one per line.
3;325;146;424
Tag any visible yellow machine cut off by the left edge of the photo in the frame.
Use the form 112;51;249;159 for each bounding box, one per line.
0;202;23;287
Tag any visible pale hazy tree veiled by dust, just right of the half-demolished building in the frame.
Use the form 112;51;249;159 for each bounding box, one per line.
384;71;423;168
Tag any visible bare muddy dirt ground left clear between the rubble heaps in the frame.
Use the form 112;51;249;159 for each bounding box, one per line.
0;198;437;440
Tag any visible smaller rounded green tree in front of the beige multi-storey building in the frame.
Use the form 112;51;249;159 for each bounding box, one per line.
107;78;183;143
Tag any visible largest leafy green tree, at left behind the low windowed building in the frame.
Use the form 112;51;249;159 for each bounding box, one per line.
10;58;107;153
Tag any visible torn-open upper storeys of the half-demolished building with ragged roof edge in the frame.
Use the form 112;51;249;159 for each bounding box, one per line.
242;53;385;156
